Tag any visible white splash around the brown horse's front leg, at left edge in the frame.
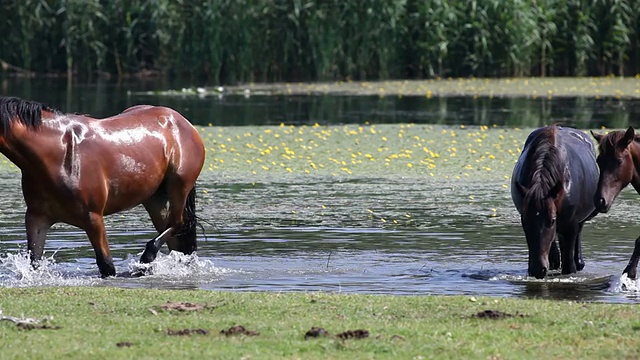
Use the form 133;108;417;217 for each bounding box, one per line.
0;252;98;287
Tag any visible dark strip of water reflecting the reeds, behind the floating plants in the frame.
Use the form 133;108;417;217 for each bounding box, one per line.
0;79;640;129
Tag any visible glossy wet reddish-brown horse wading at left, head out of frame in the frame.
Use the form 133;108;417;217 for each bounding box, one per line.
0;97;205;277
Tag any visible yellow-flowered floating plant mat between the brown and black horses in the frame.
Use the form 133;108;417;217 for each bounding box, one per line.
199;124;529;186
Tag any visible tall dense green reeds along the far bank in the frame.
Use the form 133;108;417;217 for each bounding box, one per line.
0;0;640;84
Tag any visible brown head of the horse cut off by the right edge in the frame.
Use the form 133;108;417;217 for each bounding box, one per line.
591;127;635;213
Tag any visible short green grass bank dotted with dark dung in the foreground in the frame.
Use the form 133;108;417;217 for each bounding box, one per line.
0;287;640;359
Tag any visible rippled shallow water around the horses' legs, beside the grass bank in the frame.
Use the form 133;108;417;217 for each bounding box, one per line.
0;173;640;302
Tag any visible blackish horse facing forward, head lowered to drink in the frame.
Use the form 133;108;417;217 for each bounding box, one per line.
511;126;598;279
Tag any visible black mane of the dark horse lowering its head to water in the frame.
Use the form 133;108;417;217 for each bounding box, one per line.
524;128;564;214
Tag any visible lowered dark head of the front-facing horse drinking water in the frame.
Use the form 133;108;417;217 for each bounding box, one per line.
515;181;565;279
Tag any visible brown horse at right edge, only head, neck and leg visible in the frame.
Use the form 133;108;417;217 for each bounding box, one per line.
591;127;640;279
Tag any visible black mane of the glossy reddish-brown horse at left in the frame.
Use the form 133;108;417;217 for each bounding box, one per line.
0;96;58;134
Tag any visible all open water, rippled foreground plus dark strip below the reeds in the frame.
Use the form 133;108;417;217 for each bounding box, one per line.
0;80;640;302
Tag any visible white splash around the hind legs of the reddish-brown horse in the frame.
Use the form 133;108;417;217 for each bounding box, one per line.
128;251;234;280
